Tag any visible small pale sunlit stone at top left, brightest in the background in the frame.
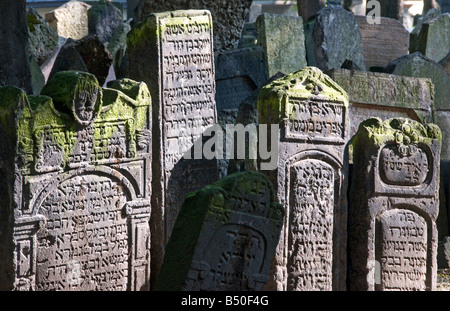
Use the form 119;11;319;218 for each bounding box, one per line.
45;0;91;40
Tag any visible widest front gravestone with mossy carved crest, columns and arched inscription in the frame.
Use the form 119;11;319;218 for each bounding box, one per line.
0;71;151;291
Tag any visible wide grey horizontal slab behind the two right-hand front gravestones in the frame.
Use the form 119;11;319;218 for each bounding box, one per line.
327;69;434;141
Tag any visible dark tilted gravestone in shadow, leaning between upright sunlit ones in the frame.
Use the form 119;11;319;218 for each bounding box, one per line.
155;172;284;291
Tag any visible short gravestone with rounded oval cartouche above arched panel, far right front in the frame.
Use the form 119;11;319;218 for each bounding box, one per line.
349;118;441;290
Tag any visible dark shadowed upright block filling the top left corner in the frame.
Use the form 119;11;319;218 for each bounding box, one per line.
0;0;33;94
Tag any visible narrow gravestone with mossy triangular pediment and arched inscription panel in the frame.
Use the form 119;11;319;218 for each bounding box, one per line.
258;67;349;291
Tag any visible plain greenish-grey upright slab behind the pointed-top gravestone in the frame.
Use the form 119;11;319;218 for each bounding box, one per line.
255;14;307;77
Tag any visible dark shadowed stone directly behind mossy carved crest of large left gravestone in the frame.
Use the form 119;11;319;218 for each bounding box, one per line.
50;36;113;85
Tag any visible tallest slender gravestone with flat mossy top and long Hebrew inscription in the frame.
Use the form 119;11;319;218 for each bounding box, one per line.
127;10;218;284
